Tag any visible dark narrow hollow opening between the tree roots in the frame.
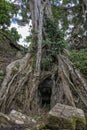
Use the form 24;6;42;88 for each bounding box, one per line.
38;78;53;109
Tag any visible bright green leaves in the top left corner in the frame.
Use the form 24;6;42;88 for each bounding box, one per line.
0;0;15;29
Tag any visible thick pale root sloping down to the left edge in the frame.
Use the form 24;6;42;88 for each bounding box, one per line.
0;54;32;112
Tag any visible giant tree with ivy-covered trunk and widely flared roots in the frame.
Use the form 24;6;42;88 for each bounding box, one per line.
0;0;87;112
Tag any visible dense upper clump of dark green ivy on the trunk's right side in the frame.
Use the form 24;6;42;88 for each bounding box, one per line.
44;18;65;56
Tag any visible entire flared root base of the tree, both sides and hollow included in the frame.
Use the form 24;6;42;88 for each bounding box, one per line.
0;50;87;113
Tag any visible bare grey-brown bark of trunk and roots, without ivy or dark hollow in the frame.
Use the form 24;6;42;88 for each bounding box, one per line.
0;0;87;115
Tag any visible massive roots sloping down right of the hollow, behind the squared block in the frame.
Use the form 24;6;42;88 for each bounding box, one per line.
55;52;87;107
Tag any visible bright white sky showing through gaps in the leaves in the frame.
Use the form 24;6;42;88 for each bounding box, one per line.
7;0;78;47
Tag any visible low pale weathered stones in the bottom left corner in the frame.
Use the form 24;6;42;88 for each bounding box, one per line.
0;110;37;130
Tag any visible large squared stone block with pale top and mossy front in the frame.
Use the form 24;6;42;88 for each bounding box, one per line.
47;103;86;130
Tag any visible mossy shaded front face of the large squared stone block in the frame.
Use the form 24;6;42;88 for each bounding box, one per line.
47;116;86;130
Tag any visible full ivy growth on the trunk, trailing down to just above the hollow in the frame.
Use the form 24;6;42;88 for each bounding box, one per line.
42;18;65;70
